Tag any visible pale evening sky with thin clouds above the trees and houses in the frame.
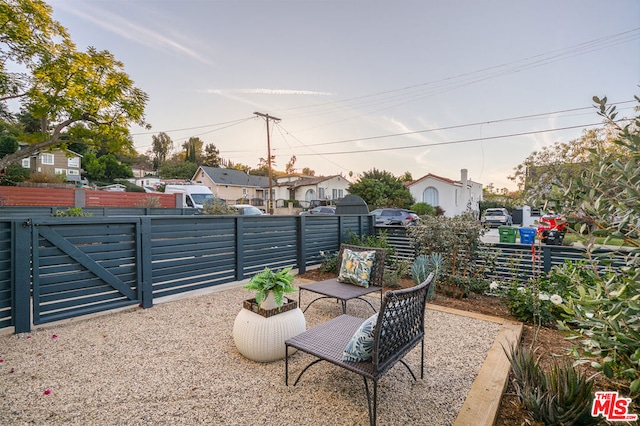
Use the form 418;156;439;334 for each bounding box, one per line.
48;0;640;189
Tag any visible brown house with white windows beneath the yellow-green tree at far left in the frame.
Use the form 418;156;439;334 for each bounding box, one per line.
20;143;82;182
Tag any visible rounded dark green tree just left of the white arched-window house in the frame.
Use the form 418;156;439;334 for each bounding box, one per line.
348;169;414;208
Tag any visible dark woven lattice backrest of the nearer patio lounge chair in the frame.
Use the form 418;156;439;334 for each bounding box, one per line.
372;273;434;374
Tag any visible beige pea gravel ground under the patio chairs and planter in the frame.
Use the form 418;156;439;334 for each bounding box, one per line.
0;287;499;425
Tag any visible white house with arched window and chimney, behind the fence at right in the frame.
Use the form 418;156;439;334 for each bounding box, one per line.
407;169;482;217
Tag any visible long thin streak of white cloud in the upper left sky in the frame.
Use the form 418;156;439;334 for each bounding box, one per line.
56;2;211;64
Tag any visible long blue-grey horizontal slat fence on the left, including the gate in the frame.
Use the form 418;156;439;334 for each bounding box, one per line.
0;210;373;333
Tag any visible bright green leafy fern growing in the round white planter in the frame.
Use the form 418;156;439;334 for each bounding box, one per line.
244;267;296;309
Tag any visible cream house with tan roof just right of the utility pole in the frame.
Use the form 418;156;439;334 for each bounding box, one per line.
274;175;350;207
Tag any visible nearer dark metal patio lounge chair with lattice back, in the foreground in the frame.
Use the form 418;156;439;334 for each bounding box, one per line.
285;274;433;425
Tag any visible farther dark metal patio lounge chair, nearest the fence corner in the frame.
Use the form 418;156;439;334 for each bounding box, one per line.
298;244;387;314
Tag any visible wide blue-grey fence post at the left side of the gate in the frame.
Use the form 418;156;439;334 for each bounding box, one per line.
11;219;33;334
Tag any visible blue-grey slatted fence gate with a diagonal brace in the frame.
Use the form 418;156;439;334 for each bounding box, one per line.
31;218;142;324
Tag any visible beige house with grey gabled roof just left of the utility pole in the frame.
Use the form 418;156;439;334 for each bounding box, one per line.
191;166;269;205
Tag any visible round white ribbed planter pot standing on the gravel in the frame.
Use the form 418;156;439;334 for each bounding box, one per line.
233;308;307;362
